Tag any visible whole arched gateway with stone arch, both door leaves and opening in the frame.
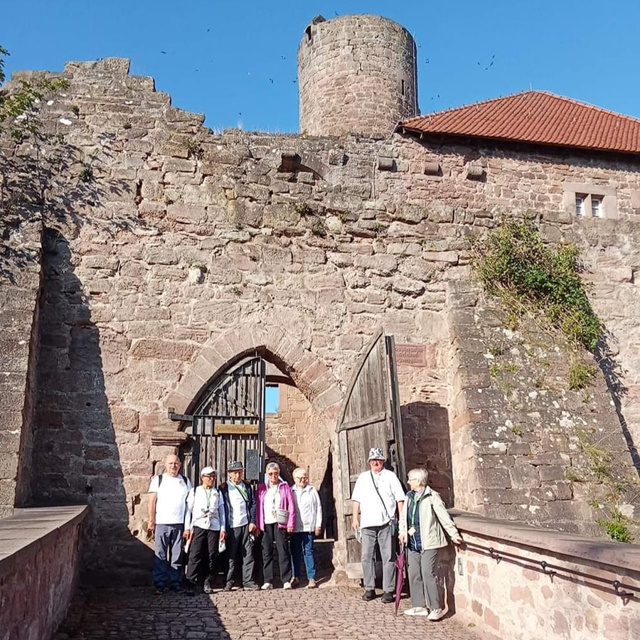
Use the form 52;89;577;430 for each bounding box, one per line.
168;327;404;578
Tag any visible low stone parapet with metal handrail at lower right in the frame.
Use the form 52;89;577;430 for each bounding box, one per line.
448;513;640;640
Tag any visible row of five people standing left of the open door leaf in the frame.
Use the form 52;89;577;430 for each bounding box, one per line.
148;455;322;594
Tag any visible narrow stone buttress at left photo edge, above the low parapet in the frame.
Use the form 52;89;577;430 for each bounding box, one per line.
0;216;42;517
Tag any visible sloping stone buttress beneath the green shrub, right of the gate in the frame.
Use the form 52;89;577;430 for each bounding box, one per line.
450;283;640;537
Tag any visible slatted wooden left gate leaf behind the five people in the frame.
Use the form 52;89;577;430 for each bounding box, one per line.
182;356;266;486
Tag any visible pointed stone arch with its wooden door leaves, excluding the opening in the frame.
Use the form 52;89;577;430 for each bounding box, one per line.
167;327;405;578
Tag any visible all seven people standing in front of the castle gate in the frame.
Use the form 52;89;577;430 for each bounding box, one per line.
149;447;462;621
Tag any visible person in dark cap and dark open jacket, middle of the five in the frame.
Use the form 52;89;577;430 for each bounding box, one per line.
220;462;260;591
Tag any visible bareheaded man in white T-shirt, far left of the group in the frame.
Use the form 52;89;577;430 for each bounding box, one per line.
148;454;191;595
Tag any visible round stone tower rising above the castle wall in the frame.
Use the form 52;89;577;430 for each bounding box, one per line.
298;15;418;136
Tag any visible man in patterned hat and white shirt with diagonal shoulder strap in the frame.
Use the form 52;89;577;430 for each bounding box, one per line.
351;447;405;602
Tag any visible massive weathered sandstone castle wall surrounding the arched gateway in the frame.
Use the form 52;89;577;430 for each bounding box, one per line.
3;57;640;577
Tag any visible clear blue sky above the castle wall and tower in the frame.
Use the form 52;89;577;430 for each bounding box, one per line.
0;0;640;132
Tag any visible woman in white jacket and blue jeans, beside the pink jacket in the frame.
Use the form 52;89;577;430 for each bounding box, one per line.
291;467;322;589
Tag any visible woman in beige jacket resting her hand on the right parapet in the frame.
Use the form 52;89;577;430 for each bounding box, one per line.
400;469;462;621
